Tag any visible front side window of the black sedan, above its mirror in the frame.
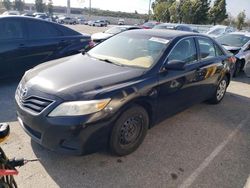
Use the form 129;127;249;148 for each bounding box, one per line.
168;38;197;64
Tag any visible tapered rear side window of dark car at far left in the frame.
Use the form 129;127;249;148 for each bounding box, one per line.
28;21;60;39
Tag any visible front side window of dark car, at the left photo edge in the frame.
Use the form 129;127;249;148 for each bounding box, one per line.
0;19;24;40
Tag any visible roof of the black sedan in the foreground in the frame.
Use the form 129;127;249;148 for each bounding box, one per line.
126;29;206;40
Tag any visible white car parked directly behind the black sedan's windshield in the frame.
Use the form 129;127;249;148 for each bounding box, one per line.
91;25;141;43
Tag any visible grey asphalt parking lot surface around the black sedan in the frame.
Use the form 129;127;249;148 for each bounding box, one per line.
0;25;250;188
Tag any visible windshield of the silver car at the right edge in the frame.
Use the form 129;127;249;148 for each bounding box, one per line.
217;34;250;47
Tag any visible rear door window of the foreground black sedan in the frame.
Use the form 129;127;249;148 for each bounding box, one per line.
198;38;216;59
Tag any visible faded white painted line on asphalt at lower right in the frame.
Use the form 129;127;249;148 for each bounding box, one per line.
179;118;248;188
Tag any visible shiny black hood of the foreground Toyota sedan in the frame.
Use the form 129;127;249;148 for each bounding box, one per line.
23;54;145;100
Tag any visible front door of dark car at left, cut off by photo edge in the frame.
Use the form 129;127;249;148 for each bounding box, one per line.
0;18;26;78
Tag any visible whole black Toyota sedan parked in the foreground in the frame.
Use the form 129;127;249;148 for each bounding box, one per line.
15;30;235;156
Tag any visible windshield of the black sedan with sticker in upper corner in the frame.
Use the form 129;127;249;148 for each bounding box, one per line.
88;33;169;69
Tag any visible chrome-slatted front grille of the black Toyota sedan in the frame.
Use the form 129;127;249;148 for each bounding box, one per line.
19;96;53;114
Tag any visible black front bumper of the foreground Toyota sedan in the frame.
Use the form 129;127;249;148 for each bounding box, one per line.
16;89;116;155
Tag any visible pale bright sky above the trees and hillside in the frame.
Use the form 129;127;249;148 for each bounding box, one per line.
25;0;250;19
